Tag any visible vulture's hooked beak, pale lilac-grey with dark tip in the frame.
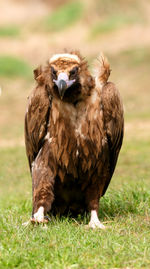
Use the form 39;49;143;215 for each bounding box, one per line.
53;72;75;99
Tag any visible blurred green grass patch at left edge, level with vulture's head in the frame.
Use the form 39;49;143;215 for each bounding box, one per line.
0;55;32;78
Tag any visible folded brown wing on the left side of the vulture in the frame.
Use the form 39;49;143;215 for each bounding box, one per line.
25;82;52;170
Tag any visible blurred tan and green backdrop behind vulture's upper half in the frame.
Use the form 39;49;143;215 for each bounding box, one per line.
0;0;150;147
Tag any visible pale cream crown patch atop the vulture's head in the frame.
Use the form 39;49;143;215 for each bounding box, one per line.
49;53;80;64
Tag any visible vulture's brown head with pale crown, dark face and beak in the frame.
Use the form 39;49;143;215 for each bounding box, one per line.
34;52;94;103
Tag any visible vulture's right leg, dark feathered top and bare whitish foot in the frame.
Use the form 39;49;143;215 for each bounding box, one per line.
86;180;105;229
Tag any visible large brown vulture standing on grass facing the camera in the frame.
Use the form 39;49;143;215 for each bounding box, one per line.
25;52;124;229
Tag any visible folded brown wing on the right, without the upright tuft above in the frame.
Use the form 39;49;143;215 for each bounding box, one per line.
102;82;124;195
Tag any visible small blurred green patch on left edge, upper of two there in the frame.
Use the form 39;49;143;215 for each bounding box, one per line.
0;26;20;38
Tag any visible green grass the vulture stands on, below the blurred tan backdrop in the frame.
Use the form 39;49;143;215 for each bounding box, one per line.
0;137;150;269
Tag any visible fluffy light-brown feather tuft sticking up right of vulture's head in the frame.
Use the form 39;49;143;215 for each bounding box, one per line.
96;53;111;85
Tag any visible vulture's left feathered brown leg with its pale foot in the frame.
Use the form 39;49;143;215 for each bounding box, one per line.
31;158;54;223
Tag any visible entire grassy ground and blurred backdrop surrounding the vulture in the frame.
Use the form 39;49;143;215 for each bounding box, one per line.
0;0;150;269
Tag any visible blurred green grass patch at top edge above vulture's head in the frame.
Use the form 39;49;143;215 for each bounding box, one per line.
43;1;83;31
